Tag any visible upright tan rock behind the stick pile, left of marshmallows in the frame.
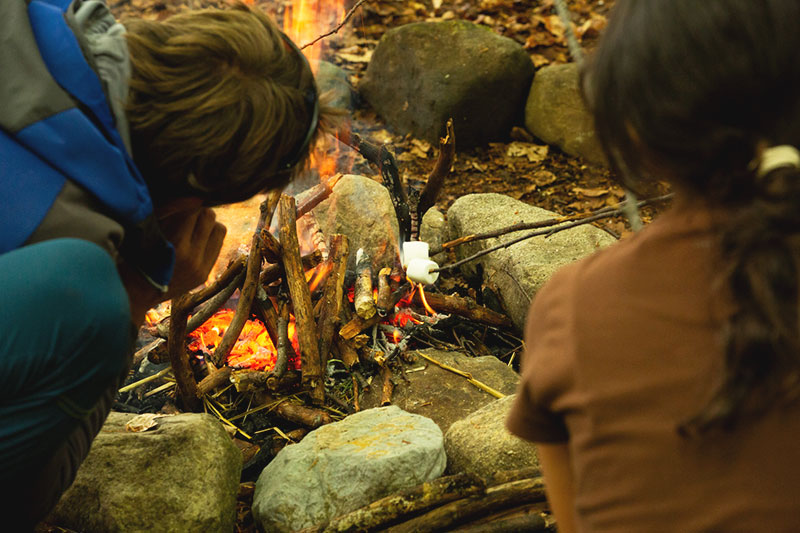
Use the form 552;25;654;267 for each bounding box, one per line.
314;175;399;272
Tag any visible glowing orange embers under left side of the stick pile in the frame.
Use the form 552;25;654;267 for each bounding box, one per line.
188;309;300;371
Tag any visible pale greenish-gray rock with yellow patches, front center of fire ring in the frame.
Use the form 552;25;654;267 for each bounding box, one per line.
253;406;447;533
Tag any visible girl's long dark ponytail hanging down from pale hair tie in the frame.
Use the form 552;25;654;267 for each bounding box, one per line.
679;152;800;435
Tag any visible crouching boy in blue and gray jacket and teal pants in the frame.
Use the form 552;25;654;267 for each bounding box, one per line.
0;0;329;530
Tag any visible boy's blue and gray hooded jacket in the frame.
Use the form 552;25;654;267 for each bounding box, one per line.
0;0;174;288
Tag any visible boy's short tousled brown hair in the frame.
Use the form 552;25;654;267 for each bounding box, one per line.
125;4;317;205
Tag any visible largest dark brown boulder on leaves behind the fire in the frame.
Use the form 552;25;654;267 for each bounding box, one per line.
358;20;534;148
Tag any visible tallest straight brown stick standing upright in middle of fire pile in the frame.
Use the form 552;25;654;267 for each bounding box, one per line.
279;195;325;404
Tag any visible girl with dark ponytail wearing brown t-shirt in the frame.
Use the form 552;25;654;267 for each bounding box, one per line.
508;0;800;532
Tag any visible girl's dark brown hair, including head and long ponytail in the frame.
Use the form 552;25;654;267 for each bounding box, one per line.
582;0;800;432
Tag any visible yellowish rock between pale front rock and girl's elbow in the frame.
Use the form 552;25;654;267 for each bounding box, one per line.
444;395;539;479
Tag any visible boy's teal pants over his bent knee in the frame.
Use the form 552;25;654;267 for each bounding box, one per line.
0;239;132;530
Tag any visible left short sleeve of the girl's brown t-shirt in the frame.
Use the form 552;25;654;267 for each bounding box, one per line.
506;265;576;443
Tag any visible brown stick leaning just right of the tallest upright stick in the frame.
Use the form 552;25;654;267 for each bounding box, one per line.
319;234;349;368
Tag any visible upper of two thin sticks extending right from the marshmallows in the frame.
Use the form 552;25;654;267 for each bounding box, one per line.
430;194;673;255
